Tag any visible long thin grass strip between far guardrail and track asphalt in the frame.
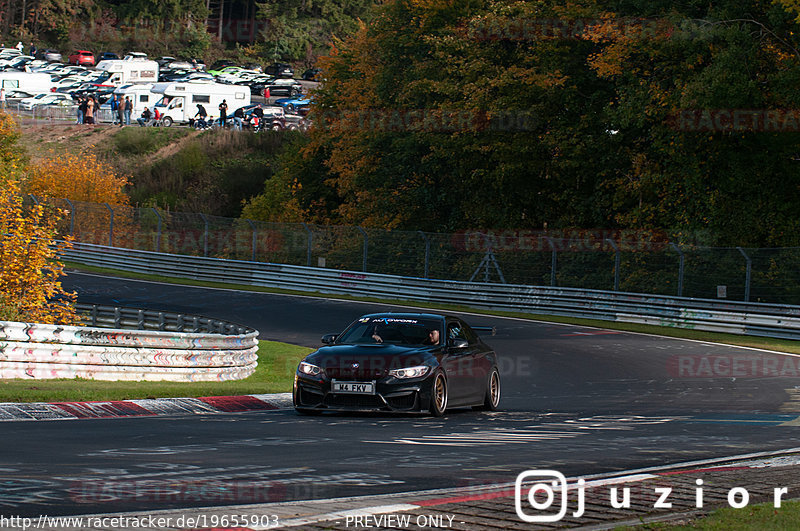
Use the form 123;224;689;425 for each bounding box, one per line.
65;262;800;354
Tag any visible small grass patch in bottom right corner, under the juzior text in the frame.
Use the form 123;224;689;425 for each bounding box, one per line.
632;501;800;531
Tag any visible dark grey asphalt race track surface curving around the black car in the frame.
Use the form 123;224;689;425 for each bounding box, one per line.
0;274;800;516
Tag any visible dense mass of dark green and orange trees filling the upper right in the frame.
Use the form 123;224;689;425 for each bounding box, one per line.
247;0;800;246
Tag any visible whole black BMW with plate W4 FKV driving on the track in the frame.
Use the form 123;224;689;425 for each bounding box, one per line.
293;313;500;417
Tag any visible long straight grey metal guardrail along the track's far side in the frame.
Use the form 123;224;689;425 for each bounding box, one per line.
65;243;800;339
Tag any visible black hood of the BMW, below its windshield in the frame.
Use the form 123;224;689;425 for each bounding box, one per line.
305;344;438;378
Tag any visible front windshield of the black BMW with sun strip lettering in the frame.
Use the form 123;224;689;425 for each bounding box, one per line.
336;317;441;346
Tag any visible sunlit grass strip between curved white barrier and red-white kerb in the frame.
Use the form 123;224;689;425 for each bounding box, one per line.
0;341;312;402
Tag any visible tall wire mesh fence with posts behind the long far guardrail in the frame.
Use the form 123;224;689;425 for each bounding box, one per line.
42;197;800;304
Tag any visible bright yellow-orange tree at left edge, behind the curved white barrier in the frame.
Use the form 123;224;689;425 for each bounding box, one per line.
0;112;77;324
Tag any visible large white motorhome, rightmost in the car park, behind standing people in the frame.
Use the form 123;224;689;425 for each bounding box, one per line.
152;83;250;127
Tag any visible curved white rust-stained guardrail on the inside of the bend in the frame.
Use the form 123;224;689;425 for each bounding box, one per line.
0;305;258;382
